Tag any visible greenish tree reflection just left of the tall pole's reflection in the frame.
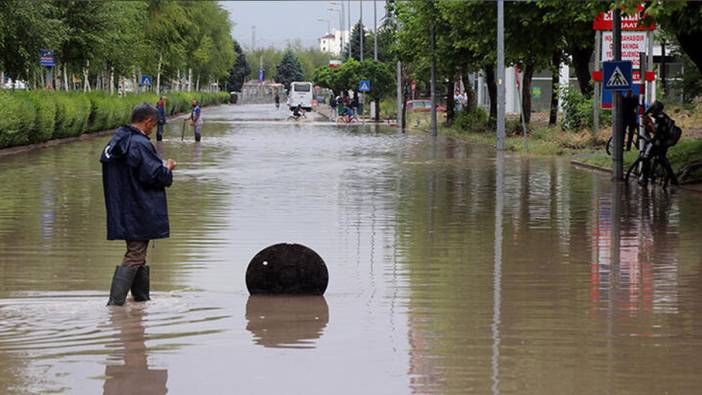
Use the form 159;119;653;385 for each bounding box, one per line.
395;141;495;393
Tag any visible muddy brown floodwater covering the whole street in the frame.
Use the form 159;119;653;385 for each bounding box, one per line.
0;105;702;394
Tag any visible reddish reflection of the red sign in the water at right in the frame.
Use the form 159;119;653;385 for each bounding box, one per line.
590;184;679;322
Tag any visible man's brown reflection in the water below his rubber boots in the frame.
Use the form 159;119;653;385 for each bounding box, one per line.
103;306;168;395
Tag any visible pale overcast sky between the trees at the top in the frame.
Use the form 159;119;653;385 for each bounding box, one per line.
220;0;385;50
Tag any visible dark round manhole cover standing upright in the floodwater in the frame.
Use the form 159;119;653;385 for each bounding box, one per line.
246;243;329;295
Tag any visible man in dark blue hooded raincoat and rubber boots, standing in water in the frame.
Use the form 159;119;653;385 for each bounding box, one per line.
100;103;176;306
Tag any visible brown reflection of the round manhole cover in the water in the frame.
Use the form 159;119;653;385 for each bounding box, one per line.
246;295;329;348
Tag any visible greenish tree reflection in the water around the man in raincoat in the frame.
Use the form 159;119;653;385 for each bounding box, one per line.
0;136;230;291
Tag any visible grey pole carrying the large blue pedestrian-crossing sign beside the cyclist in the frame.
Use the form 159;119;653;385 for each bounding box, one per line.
612;7;624;182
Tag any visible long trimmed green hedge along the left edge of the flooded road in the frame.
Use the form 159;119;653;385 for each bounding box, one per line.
0;91;229;148
